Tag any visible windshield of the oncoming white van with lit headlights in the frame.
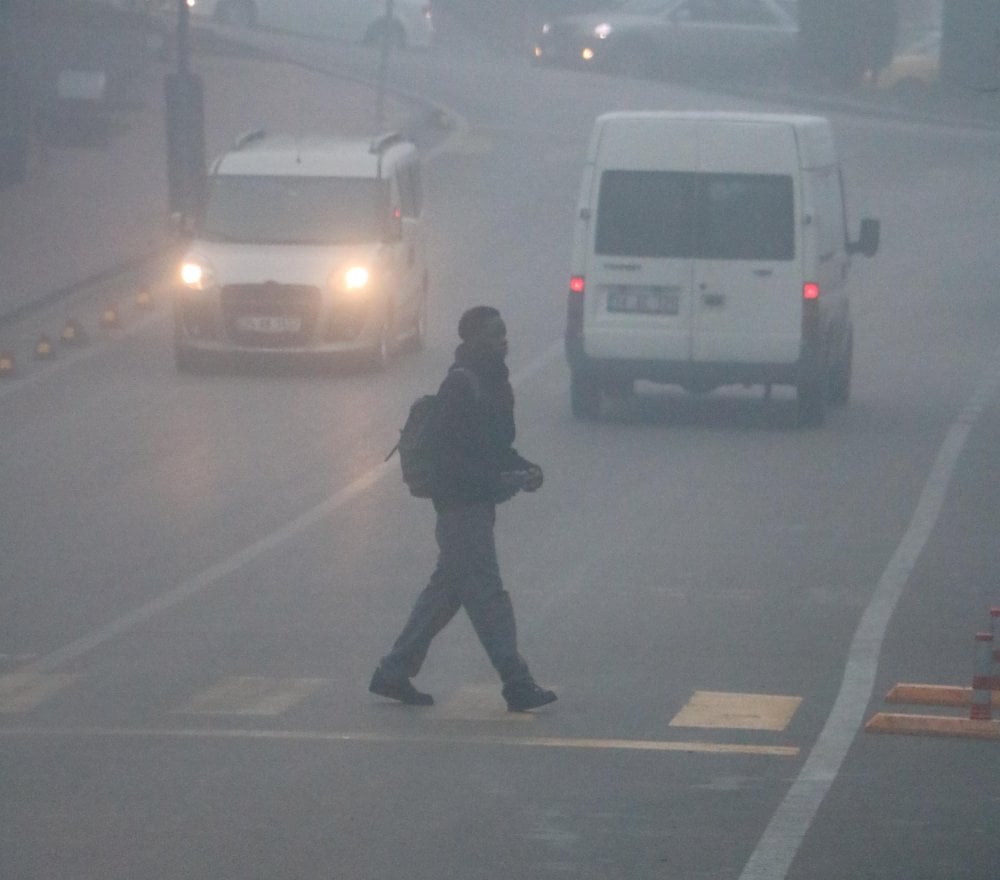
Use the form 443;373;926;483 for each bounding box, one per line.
201;174;386;245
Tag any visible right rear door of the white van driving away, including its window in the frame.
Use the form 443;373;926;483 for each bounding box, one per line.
691;120;802;364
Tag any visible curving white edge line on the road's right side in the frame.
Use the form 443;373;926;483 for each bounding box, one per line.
740;350;1000;880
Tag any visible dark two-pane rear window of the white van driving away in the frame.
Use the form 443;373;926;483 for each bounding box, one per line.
596;170;795;260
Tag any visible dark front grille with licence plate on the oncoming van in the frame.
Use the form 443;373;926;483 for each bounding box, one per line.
221;282;320;348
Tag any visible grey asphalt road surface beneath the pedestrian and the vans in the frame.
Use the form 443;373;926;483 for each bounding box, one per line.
0;25;1000;880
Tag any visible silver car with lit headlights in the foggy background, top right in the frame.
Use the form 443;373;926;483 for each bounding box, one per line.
533;0;798;81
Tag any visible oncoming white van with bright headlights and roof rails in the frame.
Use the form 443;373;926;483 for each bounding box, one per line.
174;132;429;371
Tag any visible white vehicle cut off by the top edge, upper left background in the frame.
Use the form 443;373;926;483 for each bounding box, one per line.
187;0;434;49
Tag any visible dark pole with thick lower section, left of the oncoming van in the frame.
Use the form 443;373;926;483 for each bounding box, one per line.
166;0;205;218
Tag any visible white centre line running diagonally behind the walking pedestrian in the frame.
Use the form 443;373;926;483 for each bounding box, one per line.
25;340;563;673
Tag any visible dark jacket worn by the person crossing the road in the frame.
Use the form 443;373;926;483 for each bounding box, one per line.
434;343;532;510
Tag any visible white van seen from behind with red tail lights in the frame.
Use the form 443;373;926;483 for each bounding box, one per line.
566;112;879;425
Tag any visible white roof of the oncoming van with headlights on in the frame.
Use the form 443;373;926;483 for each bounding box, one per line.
212;132;416;177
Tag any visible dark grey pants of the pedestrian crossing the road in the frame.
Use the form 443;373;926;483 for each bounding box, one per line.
381;504;531;685
